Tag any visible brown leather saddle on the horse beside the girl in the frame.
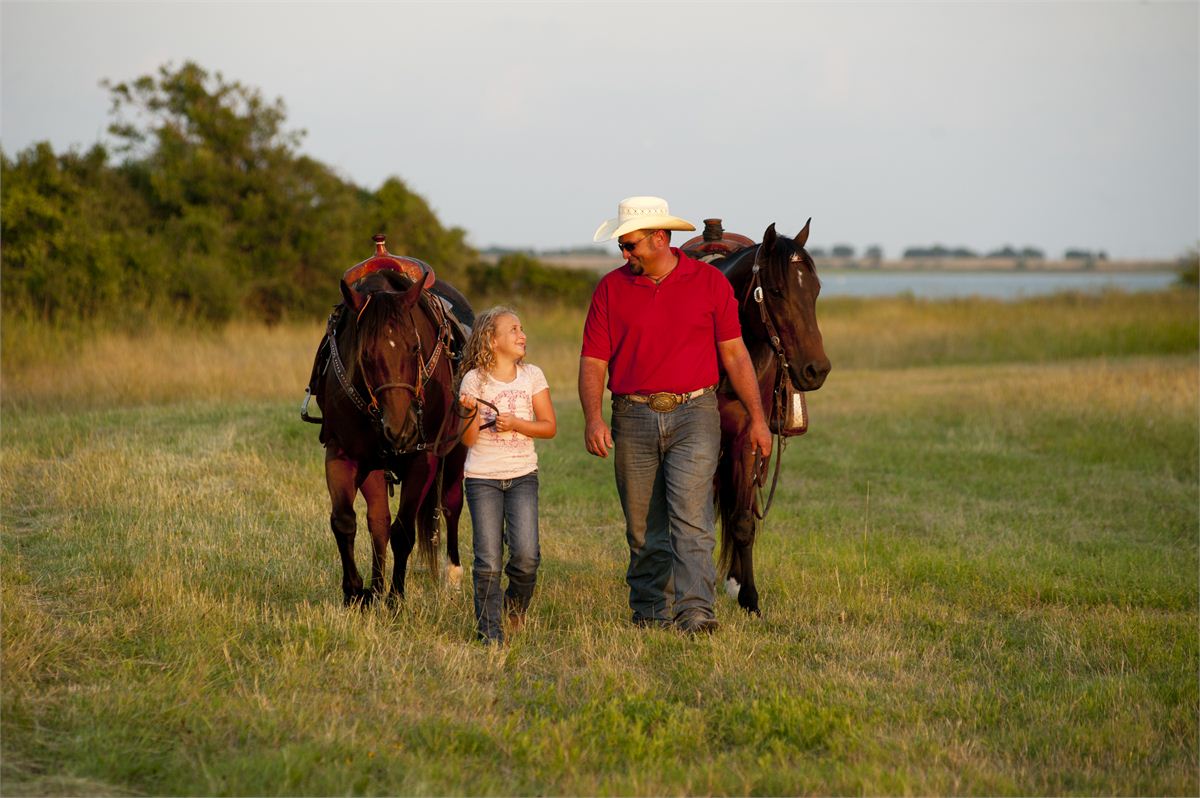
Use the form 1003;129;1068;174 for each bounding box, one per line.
300;234;475;427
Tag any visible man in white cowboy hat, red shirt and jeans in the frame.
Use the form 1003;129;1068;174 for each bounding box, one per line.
580;197;770;634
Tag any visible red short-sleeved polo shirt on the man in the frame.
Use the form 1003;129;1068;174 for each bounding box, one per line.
582;247;742;394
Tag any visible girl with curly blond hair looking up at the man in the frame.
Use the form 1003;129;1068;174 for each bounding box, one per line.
458;307;557;643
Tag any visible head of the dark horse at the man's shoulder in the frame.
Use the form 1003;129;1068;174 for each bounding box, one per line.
751;218;830;391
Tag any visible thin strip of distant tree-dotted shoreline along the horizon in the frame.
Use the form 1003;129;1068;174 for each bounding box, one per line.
480;253;1180;272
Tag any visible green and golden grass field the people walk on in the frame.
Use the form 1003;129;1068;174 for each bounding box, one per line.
0;290;1200;796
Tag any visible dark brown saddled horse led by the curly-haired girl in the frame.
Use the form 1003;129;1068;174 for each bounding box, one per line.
301;261;474;605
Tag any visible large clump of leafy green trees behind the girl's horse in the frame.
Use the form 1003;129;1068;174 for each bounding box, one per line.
0;62;475;323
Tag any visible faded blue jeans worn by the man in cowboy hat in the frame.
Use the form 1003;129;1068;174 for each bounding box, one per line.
612;394;721;623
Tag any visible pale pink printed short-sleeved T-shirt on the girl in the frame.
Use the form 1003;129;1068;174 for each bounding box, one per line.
460;364;550;479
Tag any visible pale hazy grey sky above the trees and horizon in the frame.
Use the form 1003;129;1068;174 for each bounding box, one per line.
0;0;1200;258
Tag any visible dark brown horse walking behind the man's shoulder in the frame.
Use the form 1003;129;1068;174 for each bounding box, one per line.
712;220;829;614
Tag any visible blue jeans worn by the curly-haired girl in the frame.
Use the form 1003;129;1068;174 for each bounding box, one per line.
463;470;541;643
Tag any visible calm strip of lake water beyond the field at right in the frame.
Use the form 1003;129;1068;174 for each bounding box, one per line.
821;271;1177;300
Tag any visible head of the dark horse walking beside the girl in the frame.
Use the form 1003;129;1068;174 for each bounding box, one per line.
342;271;438;450
